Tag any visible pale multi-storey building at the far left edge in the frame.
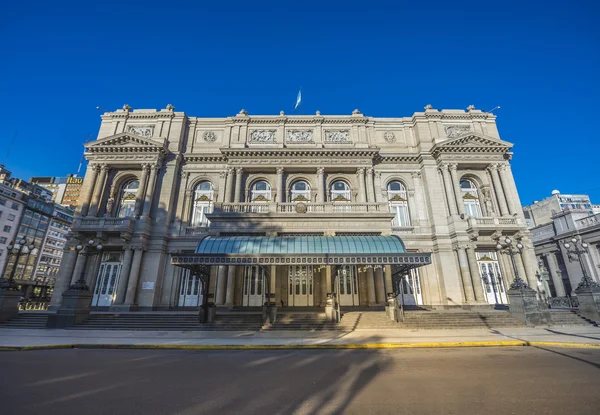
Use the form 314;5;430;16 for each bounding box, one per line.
0;180;25;276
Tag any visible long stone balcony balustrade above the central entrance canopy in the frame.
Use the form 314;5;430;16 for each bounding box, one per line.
215;202;389;213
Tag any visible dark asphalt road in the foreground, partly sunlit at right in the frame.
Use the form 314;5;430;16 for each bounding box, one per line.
0;347;600;415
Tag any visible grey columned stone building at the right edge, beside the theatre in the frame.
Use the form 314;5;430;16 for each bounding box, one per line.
531;209;600;297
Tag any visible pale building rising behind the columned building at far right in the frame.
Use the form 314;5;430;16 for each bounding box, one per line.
523;190;594;228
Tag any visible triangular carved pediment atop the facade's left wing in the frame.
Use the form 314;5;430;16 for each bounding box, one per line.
85;133;167;154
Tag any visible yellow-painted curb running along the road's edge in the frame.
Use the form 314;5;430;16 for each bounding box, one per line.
0;340;600;351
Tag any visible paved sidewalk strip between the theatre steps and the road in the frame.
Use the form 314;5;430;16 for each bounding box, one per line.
0;326;600;350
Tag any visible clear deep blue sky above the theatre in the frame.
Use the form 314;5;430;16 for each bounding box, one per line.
0;0;600;204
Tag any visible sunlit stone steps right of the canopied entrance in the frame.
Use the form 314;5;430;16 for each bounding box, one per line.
398;310;525;330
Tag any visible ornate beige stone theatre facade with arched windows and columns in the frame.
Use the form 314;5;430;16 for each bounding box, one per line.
51;105;537;310
